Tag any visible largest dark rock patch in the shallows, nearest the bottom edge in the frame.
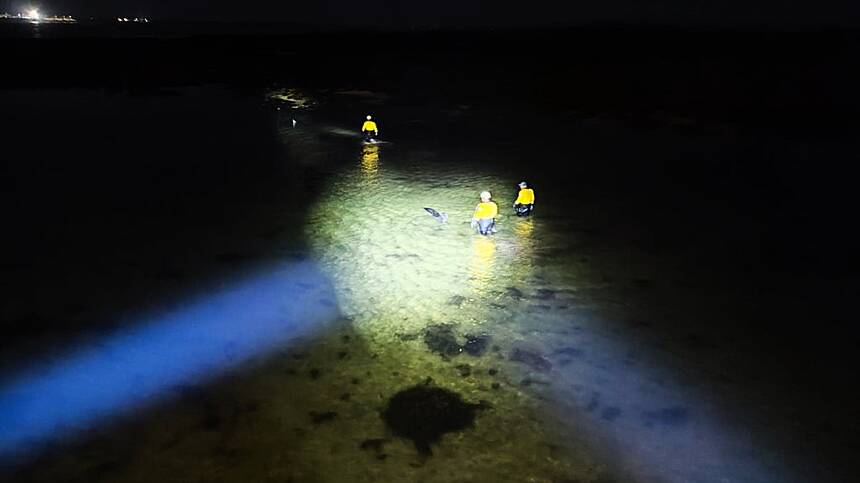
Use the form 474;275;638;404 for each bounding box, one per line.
382;385;484;456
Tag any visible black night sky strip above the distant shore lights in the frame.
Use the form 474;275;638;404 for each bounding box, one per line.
6;0;860;28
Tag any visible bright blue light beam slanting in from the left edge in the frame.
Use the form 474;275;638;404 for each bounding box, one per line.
0;262;339;459
